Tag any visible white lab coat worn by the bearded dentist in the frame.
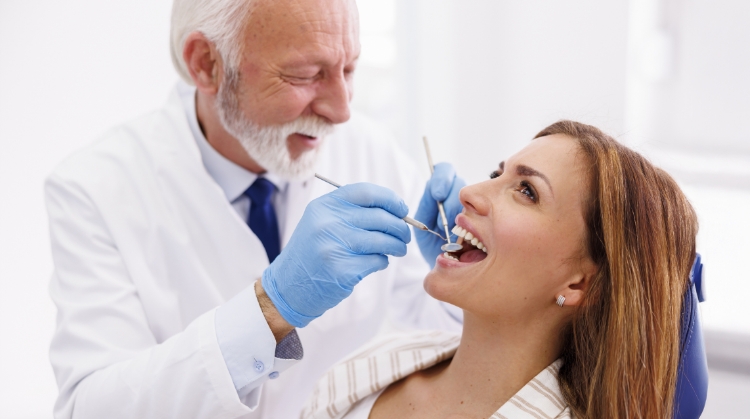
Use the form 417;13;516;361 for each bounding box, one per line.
45;86;459;419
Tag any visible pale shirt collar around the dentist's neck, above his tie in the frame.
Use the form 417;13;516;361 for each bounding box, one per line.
177;81;288;202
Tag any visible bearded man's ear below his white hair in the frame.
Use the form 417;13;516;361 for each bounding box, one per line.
182;32;223;96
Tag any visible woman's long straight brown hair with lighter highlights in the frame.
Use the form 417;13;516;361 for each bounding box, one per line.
535;121;698;419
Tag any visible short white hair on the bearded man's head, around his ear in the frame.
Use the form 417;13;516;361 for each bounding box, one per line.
170;0;257;84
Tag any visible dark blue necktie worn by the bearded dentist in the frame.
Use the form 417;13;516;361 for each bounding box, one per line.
245;177;281;262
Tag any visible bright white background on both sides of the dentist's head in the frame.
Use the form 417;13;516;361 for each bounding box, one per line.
0;0;750;418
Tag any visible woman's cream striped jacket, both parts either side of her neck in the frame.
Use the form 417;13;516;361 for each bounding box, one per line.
300;331;572;419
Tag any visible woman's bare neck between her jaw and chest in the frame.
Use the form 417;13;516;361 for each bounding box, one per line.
433;312;562;414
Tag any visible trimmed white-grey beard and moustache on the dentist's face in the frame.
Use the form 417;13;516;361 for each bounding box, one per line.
216;70;334;180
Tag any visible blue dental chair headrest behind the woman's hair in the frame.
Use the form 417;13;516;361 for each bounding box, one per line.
674;254;708;419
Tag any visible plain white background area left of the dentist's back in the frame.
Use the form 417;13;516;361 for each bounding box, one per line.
0;0;176;419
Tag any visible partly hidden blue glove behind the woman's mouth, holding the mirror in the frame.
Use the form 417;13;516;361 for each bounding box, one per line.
414;163;466;268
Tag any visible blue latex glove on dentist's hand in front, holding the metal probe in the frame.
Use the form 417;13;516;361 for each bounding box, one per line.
262;183;411;327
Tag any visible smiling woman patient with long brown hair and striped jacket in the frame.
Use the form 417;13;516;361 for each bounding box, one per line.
302;121;697;419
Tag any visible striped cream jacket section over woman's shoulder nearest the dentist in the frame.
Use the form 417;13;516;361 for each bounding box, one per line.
301;331;461;419
